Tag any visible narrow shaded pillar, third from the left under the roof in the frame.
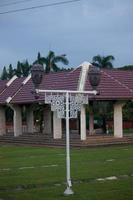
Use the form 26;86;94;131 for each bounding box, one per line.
26;106;34;133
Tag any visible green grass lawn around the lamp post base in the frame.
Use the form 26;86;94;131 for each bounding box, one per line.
0;145;133;200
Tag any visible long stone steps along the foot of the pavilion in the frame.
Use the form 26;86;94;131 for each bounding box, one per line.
0;134;133;147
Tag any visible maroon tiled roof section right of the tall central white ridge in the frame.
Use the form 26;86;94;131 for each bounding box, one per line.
85;70;133;100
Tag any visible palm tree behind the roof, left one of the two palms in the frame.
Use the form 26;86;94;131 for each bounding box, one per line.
34;51;69;73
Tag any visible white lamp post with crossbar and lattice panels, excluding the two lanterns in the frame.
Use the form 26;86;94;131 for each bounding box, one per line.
35;89;98;196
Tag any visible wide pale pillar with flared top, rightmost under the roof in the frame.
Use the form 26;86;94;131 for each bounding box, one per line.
114;102;124;138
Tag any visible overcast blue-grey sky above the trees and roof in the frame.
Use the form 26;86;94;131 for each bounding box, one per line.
0;0;133;69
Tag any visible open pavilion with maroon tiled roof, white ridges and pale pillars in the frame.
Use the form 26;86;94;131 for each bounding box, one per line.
0;62;133;140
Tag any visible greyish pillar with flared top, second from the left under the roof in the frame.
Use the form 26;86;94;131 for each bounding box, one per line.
10;105;22;137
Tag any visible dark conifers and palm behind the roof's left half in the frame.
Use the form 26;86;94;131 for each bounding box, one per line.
1;51;70;80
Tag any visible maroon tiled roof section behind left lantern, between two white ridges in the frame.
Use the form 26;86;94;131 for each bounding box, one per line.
11;69;80;103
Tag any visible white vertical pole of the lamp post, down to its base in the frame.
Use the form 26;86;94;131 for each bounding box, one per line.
64;92;74;196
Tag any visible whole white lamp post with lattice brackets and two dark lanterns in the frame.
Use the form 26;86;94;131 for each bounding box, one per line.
31;64;100;195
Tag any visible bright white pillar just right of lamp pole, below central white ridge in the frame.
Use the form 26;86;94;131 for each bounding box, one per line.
80;105;86;140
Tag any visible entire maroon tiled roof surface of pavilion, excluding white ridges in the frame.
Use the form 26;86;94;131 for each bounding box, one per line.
0;68;133;104
